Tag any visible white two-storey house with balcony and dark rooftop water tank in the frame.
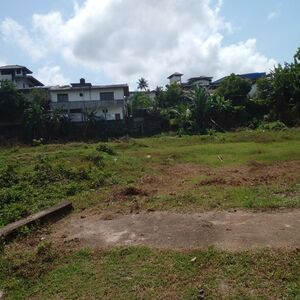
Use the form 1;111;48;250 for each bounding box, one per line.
49;78;129;122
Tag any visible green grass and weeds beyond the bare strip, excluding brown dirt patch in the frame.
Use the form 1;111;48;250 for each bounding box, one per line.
0;129;300;227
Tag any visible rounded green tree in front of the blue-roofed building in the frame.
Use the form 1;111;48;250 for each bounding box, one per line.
216;74;251;106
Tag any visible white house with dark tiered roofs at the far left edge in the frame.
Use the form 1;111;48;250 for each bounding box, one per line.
0;65;44;90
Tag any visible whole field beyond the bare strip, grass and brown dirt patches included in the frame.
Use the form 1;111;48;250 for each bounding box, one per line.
0;130;300;227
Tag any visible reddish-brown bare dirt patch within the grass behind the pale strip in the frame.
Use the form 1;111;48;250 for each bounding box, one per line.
110;161;300;201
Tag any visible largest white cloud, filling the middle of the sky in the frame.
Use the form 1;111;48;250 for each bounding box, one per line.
1;0;275;87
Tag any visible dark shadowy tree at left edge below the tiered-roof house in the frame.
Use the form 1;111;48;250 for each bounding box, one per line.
0;80;27;123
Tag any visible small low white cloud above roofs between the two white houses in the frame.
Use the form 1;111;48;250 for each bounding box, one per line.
36;66;70;85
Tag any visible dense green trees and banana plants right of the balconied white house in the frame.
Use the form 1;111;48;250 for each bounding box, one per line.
132;49;300;133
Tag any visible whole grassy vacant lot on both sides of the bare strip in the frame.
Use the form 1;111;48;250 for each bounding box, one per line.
0;129;300;299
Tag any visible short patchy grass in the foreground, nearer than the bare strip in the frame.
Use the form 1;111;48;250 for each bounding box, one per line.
0;245;300;300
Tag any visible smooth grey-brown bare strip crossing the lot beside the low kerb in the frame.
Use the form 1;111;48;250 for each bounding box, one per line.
47;209;300;251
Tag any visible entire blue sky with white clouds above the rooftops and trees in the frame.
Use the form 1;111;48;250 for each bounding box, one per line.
0;0;300;89
